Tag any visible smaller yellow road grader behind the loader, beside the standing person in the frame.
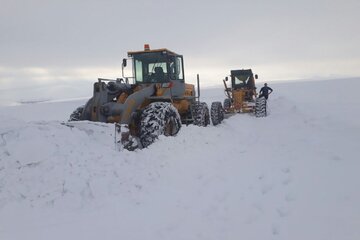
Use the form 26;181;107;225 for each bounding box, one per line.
211;69;266;125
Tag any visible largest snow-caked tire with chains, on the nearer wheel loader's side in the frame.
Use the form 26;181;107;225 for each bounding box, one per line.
139;102;181;147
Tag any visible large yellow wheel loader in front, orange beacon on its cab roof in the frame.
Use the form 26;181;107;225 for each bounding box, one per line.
69;44;214;150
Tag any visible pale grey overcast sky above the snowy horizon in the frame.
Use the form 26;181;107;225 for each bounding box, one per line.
0;0;360;101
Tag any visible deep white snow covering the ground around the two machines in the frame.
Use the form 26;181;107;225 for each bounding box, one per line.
0;79;360;240
